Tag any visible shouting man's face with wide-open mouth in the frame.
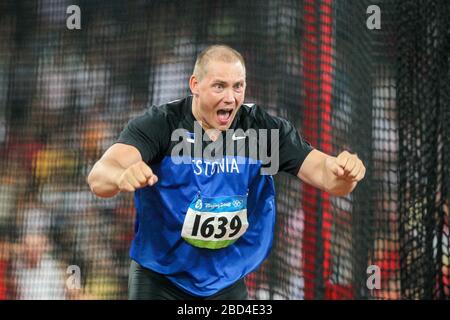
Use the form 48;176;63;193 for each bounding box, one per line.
189;61;245;130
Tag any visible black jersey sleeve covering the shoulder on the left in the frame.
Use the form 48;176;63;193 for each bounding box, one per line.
116;106;170;163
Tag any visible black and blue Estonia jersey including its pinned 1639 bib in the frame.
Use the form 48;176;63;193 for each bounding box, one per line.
114;97;312;297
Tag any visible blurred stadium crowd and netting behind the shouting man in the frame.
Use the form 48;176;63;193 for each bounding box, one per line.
0;0;450;299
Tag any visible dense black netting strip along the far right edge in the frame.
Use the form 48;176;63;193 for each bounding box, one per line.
397;1;450;299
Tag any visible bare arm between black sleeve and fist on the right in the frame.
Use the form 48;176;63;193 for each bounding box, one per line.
297;149;329;191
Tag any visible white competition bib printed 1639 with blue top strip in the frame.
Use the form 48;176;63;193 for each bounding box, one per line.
181;195;248;249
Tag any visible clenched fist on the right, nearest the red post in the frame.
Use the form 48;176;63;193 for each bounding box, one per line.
326;151;366;182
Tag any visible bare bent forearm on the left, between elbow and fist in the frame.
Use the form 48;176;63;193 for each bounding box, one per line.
87;160;125;198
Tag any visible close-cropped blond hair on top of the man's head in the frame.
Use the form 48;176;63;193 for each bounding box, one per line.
193;45;245;81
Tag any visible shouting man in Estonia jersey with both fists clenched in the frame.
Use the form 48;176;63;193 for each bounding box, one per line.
88;45;365;299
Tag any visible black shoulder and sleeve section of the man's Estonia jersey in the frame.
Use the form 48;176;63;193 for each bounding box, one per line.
117;96;313;175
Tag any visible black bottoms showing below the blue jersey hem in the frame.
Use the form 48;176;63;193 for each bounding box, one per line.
128;260;248;300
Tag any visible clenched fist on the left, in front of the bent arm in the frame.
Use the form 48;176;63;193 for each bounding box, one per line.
117;161;158;192
